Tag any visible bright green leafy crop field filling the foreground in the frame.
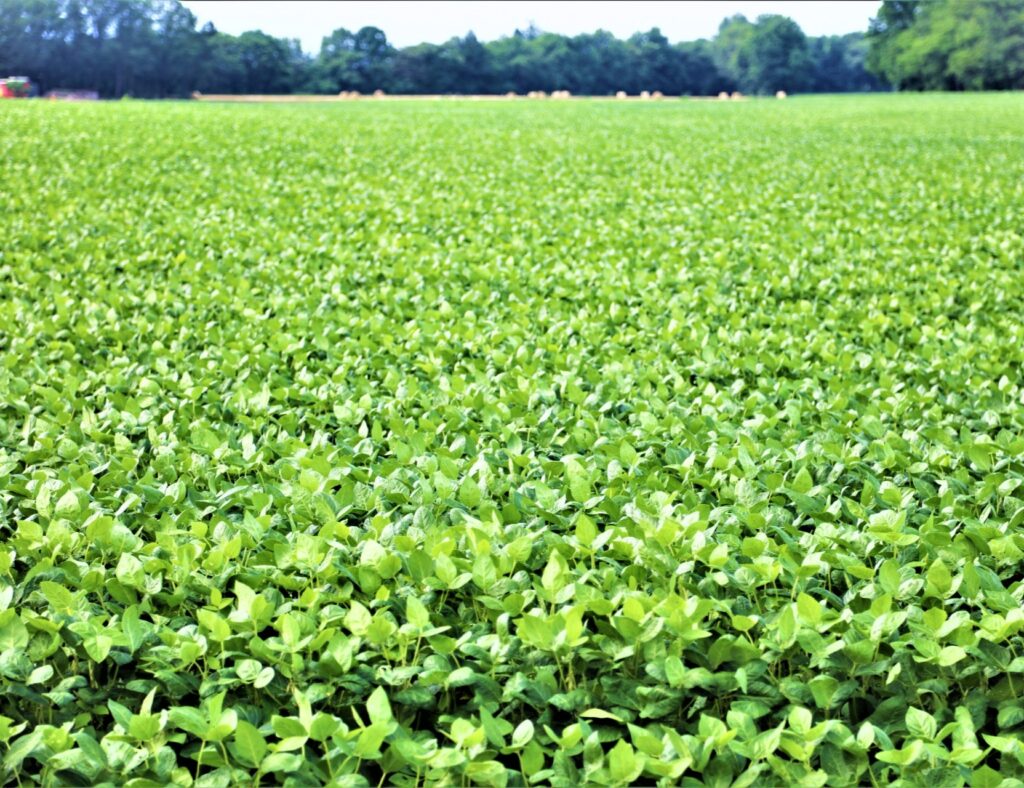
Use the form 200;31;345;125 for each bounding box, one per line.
0;95;1024;788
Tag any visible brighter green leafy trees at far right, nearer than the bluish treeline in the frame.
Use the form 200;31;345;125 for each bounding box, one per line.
868;0;1024;90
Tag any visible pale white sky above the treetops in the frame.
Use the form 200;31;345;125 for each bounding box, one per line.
184;0;881;52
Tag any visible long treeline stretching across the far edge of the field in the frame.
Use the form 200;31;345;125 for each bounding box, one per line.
0;0;1024;97
